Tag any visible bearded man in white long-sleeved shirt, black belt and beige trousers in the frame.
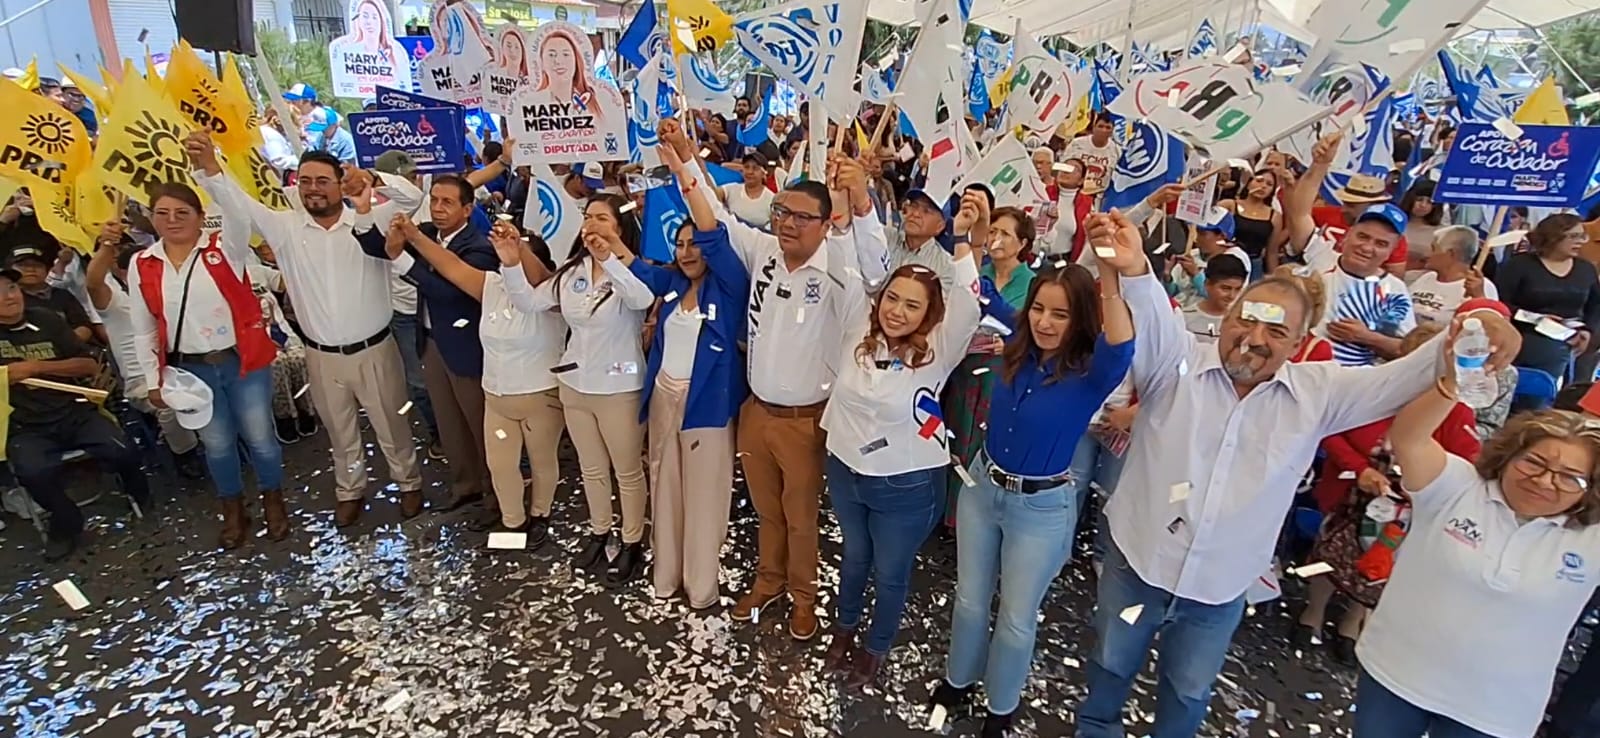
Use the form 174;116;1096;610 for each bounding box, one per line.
195;133;422;528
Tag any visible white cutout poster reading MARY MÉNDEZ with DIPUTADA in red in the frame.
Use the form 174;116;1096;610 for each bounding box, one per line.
507;22;627;165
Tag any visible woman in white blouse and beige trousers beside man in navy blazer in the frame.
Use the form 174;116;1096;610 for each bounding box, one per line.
384;223;566;549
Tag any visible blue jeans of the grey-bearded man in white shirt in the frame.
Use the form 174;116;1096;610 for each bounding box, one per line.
1077;544;1245;738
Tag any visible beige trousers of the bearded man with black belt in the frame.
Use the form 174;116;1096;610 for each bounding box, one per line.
306;338;422;503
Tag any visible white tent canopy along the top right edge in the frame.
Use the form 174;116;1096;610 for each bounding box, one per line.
867;0;1600;48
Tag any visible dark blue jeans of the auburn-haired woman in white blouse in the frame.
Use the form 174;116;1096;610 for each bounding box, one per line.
826;455;944;656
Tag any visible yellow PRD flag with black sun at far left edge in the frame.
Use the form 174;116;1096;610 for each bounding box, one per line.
0;82;93;187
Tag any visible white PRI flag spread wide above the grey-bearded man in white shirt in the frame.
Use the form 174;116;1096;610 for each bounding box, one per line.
1109;59;1328;160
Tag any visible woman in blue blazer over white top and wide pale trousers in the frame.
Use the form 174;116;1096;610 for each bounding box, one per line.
629;173;750;610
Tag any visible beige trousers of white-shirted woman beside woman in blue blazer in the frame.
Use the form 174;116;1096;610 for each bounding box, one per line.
562;384;650;543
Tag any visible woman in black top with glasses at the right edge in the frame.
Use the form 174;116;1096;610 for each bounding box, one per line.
1494;213;1600;413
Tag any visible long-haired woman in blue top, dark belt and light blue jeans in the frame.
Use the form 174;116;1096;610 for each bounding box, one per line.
933;227;1133;736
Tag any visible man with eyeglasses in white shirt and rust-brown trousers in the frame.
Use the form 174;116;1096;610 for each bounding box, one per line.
661;120;888;640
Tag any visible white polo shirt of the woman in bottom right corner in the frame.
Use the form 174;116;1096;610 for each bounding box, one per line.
1355;456;1600;738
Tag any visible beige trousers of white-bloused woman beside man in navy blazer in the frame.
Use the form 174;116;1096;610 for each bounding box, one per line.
483;389;566;528
